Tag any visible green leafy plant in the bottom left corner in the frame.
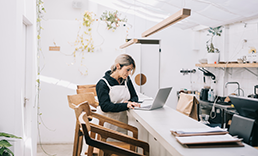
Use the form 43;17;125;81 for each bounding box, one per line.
0;132;21;156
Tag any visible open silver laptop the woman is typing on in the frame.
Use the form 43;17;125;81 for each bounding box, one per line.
134;87;172;110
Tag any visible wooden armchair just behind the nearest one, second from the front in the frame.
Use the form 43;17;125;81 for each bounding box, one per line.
67;93;145;156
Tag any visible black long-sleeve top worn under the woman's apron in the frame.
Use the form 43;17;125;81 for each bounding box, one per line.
96;70;138;112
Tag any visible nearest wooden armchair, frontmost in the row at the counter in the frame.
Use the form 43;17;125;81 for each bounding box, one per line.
74;102;149;156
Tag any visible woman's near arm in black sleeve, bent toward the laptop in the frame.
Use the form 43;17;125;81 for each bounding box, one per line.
96;80;128;112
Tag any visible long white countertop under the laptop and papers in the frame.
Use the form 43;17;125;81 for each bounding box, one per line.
129;106;258;156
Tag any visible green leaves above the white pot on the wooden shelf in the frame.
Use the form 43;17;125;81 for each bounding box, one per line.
206;26;222;53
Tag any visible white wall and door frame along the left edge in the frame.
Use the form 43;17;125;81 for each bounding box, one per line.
0;0;37;156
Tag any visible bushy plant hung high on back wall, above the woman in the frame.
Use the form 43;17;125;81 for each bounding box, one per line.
100;10;127;31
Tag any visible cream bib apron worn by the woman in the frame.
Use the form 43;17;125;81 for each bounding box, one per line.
98;78;130;134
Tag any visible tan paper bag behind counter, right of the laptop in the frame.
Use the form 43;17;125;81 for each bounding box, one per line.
176;93;199;120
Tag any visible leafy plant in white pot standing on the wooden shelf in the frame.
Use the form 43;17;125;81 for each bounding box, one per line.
206;26;222;63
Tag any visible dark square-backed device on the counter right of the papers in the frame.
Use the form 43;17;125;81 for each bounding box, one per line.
229;114;255;143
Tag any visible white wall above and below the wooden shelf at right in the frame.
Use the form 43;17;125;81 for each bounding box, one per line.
196;19;258;97
